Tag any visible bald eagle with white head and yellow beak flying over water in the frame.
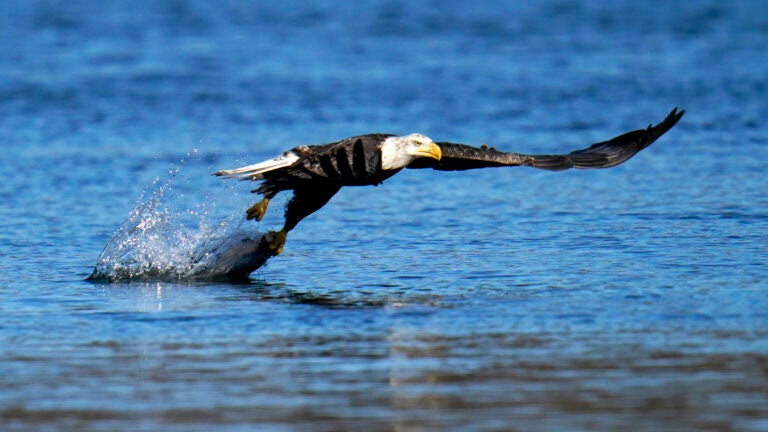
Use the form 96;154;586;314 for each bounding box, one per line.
214;108;685;255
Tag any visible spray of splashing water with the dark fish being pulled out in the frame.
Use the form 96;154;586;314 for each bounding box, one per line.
88;154;272;282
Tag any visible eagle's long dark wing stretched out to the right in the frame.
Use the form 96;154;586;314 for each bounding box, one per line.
408;108;685;171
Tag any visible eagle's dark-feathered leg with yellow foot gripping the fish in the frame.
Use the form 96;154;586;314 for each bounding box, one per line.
262;185;341;255
